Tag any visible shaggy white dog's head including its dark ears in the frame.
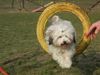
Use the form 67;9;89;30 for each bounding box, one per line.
49;28;75;48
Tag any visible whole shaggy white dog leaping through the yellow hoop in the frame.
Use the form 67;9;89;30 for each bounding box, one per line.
45;15;76;68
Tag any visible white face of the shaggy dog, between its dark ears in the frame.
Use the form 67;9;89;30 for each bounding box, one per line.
53;30;72;47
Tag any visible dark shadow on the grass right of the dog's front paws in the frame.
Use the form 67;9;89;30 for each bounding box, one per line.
73;53;100;75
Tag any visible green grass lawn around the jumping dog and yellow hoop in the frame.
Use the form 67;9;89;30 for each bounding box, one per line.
0;0;100;75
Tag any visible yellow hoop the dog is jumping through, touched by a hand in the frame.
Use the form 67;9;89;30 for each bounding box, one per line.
37;2;90;55
